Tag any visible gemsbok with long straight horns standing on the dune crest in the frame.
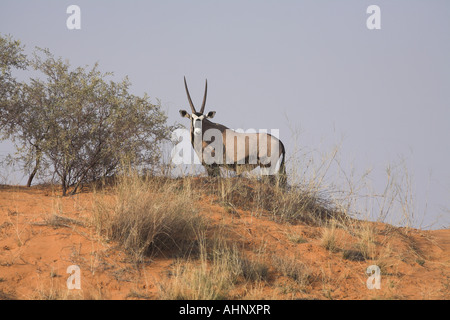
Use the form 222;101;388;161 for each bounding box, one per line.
180;78;286;186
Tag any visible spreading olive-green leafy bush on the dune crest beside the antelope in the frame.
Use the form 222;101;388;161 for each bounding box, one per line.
0;36;173;195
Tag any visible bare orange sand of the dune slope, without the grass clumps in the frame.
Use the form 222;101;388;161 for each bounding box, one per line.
0;186;450;299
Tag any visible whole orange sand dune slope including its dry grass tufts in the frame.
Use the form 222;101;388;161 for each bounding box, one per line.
0;170;449;299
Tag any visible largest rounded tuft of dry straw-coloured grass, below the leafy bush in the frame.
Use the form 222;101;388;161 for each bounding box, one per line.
94;170;205;262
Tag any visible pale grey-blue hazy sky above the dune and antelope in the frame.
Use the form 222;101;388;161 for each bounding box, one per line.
0;0;450;228
